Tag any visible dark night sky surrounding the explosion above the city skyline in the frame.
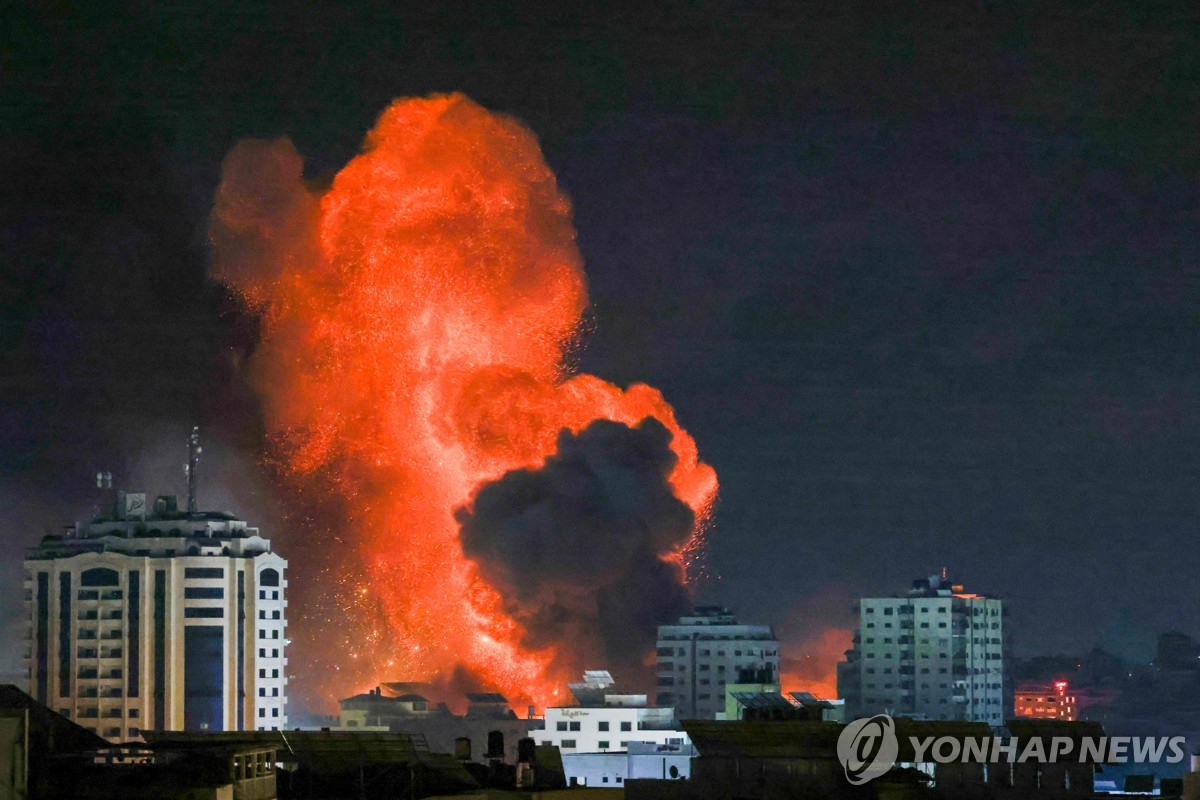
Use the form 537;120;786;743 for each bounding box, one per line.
0;0;1200;686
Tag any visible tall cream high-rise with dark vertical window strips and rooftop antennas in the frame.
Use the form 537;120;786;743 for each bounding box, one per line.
25;484;288;740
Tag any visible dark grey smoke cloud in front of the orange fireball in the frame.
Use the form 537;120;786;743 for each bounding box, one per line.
457;417;695;686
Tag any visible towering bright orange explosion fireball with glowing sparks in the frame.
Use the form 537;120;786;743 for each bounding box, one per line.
210;95;716;705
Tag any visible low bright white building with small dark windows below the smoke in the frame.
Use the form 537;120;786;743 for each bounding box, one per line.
529;670;690;762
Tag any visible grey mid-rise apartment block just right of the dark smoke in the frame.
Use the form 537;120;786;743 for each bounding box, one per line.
655;606;779;720
